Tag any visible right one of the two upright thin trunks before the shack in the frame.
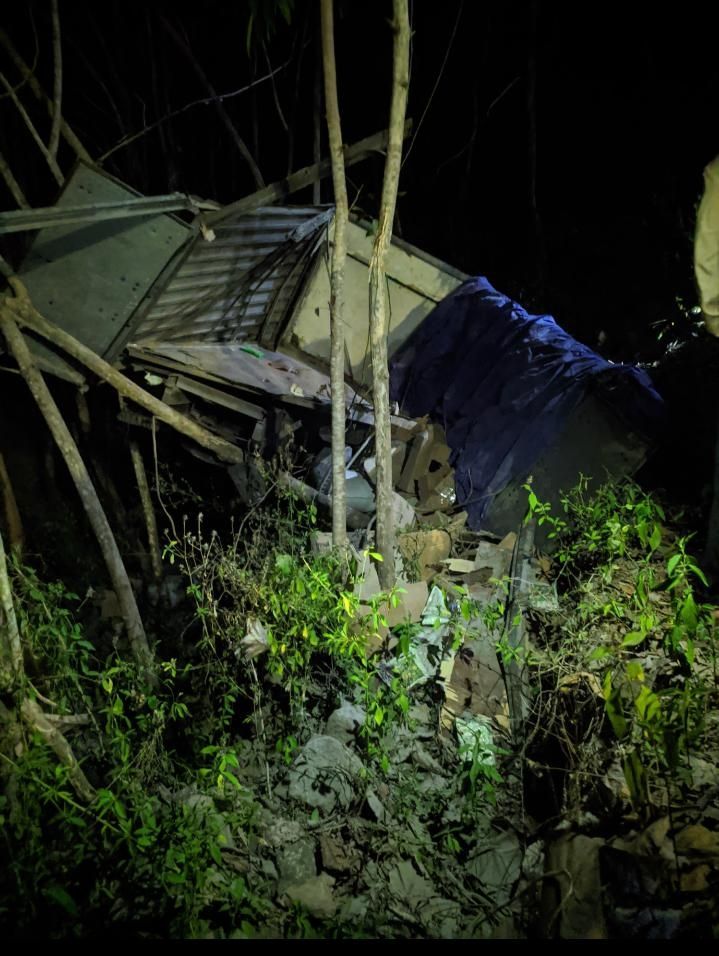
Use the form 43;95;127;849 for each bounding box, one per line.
369;0;410;589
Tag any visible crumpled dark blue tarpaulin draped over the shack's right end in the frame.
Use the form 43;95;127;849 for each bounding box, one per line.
390;276;663;528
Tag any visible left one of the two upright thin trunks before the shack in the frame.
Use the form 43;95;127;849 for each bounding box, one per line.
320;0;348;548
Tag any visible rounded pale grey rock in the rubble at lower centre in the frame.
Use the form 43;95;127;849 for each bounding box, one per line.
289;735;362;814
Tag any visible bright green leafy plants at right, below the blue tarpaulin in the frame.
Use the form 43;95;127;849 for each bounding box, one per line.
526;479;717;810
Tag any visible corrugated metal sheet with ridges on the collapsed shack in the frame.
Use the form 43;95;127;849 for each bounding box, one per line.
132;206;333;348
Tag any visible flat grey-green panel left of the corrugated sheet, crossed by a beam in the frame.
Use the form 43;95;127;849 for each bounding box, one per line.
18;164;191;363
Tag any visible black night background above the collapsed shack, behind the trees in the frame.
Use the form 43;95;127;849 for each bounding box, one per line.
0;0;719;358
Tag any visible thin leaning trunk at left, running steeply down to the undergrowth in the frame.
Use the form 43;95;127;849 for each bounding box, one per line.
0;303;152;675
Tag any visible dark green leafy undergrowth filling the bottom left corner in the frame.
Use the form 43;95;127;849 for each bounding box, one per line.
0;566;266;937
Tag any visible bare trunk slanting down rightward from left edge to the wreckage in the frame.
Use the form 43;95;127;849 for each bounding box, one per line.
0;276;244;465
